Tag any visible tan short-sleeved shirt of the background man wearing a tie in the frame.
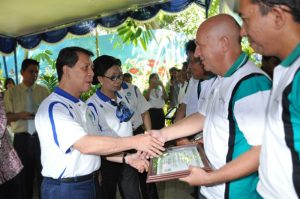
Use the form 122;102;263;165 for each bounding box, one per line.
4;83;49;133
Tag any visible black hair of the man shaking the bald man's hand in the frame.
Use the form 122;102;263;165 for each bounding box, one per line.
56;46;94;81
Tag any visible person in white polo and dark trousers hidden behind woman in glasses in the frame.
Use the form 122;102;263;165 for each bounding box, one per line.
119;62;159;199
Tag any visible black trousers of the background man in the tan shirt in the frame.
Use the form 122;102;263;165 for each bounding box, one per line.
13;133;42;199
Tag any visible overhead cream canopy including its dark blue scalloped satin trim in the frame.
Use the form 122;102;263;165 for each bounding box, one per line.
0;0;211;81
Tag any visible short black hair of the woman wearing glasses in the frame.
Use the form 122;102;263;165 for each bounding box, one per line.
93;55;121;85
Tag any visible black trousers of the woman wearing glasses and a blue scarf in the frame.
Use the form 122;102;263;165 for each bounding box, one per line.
101;158;141;199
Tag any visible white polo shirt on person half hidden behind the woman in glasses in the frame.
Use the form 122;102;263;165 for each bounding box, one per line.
119;82;151;130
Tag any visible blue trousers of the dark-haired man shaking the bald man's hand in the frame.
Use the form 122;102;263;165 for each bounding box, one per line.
41;175;103;199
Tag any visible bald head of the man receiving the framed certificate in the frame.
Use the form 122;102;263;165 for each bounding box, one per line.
195;14;241;75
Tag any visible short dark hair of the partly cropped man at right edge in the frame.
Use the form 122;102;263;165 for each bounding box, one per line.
251;0;300;23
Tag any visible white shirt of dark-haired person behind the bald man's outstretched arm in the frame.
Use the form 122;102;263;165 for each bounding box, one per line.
183;78;201;117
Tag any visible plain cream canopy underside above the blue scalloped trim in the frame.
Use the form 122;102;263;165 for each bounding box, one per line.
0;0;166;37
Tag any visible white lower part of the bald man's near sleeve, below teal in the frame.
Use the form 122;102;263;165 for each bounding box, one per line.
233;90;270;145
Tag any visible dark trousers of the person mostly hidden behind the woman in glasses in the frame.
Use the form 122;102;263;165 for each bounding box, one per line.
133;126;159;199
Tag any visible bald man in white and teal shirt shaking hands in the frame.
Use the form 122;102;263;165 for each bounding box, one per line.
151;14;271;199
